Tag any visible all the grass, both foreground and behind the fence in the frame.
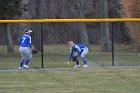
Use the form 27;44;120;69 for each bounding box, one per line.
0;45;140;93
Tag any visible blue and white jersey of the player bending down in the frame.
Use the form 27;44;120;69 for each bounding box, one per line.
68;44;88;61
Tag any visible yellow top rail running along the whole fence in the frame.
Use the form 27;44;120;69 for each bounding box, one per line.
0;18;140;23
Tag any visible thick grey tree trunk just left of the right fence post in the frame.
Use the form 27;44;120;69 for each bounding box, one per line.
100;0;111;52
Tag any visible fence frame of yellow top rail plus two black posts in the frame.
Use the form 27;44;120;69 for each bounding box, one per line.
0;18;140;68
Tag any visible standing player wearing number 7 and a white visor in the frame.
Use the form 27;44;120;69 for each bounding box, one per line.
19;30;32;69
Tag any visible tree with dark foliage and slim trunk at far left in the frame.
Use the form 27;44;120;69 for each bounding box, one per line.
0;0;26;52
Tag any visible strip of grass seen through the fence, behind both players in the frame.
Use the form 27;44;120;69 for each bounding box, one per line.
0;45;140;69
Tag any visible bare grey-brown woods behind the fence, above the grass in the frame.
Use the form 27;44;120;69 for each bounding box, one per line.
0;0;140;52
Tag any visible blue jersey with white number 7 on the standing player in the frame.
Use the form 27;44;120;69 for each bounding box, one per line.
19;34;32;48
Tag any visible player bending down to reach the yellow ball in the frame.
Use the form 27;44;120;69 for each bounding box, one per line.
68;41;89;68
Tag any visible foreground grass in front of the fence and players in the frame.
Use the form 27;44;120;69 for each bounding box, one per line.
0;69;140;93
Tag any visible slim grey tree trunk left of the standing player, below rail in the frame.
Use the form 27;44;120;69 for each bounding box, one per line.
4;24;14;52
